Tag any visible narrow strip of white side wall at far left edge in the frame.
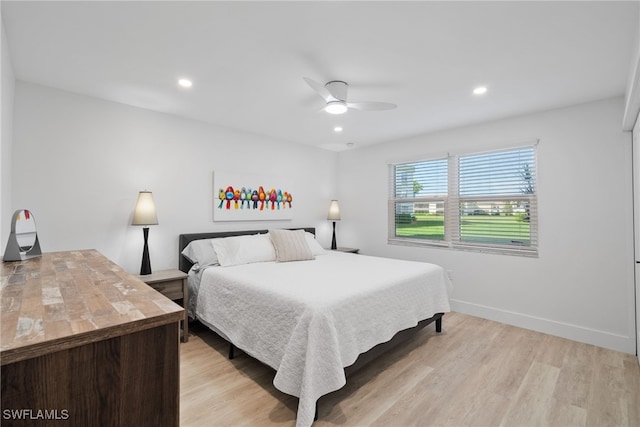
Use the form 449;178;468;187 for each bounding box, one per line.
0;13;15;254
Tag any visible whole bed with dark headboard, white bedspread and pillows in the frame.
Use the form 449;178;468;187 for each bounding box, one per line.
179;228;450;426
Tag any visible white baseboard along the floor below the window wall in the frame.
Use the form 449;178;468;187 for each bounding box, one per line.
450;299;640;354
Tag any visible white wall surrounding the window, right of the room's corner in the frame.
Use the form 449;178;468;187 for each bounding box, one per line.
338;98;635;353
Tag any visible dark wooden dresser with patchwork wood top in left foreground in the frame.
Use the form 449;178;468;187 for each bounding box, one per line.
0;250;184;427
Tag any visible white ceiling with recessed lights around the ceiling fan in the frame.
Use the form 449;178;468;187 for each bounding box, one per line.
2;1;639;150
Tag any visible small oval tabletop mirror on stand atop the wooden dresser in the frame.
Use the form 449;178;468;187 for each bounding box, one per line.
3;209;42;261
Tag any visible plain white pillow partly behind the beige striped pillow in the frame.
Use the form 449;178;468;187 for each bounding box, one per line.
213;234;276;267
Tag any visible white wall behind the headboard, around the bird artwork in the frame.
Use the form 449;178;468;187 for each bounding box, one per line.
13;81;337;273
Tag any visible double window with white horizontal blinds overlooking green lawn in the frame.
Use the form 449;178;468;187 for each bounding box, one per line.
389;146;537;255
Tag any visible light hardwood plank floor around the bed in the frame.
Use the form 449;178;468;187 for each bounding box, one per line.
180;313;640;427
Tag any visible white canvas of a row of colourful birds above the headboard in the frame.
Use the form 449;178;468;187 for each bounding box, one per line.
213;172;295;221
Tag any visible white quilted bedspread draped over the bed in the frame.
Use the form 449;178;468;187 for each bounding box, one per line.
195;252;450;426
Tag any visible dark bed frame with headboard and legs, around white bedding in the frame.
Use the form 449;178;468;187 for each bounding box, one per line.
178;227;444;420
